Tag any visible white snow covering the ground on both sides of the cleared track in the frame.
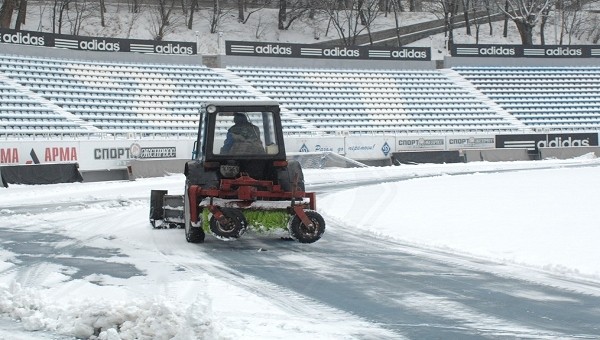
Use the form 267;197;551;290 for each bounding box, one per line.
0;155;600;339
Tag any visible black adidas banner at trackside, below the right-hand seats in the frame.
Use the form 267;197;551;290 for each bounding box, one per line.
496;132;598;152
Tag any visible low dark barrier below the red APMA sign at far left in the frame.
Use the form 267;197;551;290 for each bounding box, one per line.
0;163;83;186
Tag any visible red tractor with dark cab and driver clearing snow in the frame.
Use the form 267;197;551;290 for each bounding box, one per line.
150;101;325;243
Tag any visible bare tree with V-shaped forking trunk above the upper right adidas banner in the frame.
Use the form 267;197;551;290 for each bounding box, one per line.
498;0;550;45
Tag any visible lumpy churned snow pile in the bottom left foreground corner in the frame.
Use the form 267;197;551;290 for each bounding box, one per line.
0;282;223;340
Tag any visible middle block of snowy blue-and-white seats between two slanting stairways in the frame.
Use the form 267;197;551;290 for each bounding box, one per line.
227;66;518;134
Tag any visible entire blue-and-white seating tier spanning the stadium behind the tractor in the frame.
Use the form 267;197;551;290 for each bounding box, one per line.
0;54;600;135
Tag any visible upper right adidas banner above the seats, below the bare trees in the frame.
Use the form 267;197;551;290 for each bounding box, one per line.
451;44;600;58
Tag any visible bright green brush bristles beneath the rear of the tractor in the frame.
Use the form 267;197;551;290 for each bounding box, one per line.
202;209;290;232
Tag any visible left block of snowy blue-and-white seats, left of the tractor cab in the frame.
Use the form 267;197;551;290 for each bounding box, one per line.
0;55;324;135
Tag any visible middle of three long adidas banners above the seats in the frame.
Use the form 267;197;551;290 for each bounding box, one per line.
225;41;431;61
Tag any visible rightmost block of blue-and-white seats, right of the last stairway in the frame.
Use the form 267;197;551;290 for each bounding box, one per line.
453;67;600;131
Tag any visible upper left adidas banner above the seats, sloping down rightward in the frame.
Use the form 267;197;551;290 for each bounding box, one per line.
0;28;198;55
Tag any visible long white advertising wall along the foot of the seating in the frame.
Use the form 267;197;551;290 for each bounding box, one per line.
0;132;598;181
